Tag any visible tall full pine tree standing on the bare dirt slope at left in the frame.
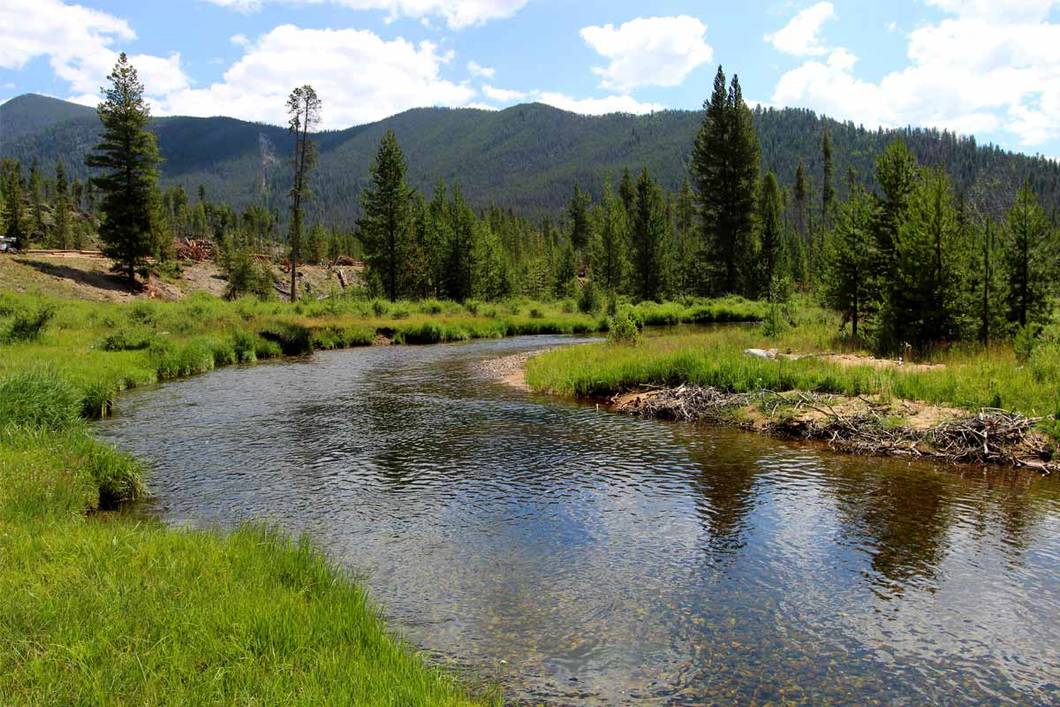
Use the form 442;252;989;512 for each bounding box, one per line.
85;52;159;283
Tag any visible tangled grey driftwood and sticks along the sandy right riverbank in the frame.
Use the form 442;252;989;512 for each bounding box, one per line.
612;386;1060;474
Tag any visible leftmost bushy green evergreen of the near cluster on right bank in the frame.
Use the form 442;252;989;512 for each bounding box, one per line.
822;187;875;340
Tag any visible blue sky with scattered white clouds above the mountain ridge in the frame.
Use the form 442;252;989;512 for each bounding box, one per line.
0;0;1060;156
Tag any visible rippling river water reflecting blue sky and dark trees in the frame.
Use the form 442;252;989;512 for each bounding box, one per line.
101;338;1060;704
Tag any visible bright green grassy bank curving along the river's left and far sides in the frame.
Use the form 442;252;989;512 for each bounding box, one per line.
0;294;759;705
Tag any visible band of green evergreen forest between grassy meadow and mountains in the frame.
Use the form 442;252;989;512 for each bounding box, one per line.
0;59;1058;354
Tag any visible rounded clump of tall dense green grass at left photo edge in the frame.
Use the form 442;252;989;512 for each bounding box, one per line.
0;369;81;429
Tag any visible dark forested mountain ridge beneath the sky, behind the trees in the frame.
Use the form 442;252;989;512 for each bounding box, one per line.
0;90;1060;225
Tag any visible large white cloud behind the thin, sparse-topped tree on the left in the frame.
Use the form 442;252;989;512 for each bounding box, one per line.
155;24;475;128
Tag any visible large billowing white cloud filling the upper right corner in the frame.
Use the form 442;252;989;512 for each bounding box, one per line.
773;0;1060;147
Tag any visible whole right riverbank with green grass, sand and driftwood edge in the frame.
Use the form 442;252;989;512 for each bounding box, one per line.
527;325;1060;473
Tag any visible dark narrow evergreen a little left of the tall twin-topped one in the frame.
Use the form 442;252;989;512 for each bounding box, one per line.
630;169;667;301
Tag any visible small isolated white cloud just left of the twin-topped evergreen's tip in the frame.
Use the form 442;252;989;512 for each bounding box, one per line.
581;15;713;91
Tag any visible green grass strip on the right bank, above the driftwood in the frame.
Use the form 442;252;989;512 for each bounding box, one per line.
527;312;1060;437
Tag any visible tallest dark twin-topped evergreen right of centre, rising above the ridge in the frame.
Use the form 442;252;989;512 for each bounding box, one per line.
691;67;759;295
